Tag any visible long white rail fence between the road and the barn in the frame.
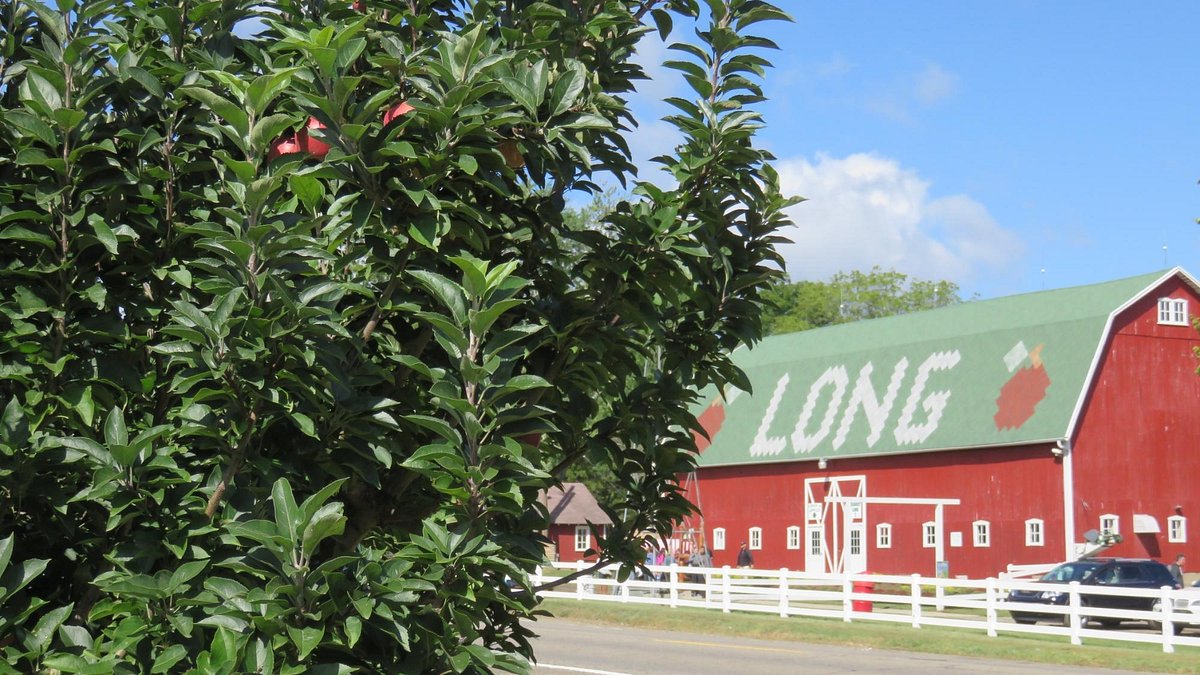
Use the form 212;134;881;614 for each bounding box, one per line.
532;563;1200;653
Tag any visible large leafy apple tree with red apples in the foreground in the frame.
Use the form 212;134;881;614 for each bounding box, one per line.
0;0;792;673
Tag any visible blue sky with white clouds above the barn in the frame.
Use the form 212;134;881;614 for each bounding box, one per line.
632;0;1200;298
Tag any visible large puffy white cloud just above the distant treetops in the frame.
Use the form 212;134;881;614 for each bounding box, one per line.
776;154;1022;285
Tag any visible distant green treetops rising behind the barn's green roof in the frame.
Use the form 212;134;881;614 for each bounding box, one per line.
763;267;962;334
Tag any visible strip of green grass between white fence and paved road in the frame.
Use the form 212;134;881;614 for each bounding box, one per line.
542;599;1200;673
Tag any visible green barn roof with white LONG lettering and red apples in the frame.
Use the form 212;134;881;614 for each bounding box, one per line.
698;269;1194;466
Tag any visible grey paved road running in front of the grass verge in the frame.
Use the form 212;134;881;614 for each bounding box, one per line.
534;619;1130;675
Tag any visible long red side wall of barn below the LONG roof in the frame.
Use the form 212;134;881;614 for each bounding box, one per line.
692;446;1064;577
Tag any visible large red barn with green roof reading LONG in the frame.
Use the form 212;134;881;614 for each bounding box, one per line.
690;269;1200;577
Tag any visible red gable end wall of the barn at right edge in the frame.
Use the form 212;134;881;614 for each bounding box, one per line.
1073;279;1200;559
